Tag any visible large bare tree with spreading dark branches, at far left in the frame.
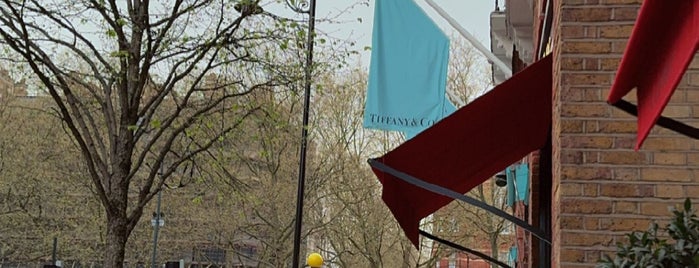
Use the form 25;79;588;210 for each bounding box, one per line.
0;0;308;267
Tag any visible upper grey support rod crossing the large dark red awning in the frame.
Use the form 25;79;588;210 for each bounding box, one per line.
368;159;551;245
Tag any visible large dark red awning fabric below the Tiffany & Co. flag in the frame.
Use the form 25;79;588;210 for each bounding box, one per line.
373;56;552;247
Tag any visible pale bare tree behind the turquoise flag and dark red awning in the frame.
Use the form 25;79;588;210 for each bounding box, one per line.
306;34;498;267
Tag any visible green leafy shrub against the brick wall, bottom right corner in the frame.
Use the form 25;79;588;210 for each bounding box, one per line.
597;198;699;268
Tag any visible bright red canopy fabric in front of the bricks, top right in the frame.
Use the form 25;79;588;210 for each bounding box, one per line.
607;0;699;150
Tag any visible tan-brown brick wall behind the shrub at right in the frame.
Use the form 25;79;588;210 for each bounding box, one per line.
552;0;699;267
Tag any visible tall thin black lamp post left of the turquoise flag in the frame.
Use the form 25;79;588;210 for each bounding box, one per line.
292;0;316;268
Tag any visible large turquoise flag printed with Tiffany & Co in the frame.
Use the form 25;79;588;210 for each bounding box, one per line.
364;0;449;133
